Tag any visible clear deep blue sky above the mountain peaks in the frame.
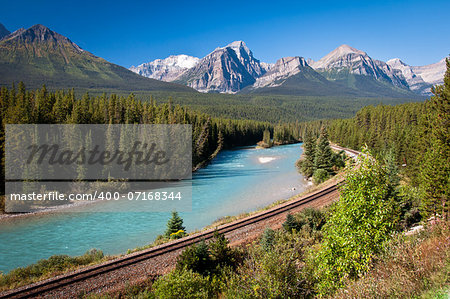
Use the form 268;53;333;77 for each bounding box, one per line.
0;0;450;67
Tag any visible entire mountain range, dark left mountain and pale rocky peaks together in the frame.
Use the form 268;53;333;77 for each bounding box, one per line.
0;24;445;98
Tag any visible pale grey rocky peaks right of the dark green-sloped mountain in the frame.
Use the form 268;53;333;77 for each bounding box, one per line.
130;41;445;97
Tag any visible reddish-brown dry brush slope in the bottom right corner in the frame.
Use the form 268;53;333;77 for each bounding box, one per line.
335;223;450;299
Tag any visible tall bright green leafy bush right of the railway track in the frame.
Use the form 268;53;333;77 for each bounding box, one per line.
316;150;398;295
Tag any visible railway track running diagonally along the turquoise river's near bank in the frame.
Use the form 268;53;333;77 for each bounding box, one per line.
0;185;337;298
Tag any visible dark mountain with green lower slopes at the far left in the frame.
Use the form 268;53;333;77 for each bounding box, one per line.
0;25;195;92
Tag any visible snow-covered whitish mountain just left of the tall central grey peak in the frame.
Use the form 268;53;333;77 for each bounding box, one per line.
130;55;200;82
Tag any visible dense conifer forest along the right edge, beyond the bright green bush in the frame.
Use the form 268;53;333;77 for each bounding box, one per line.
327;59;450;218
